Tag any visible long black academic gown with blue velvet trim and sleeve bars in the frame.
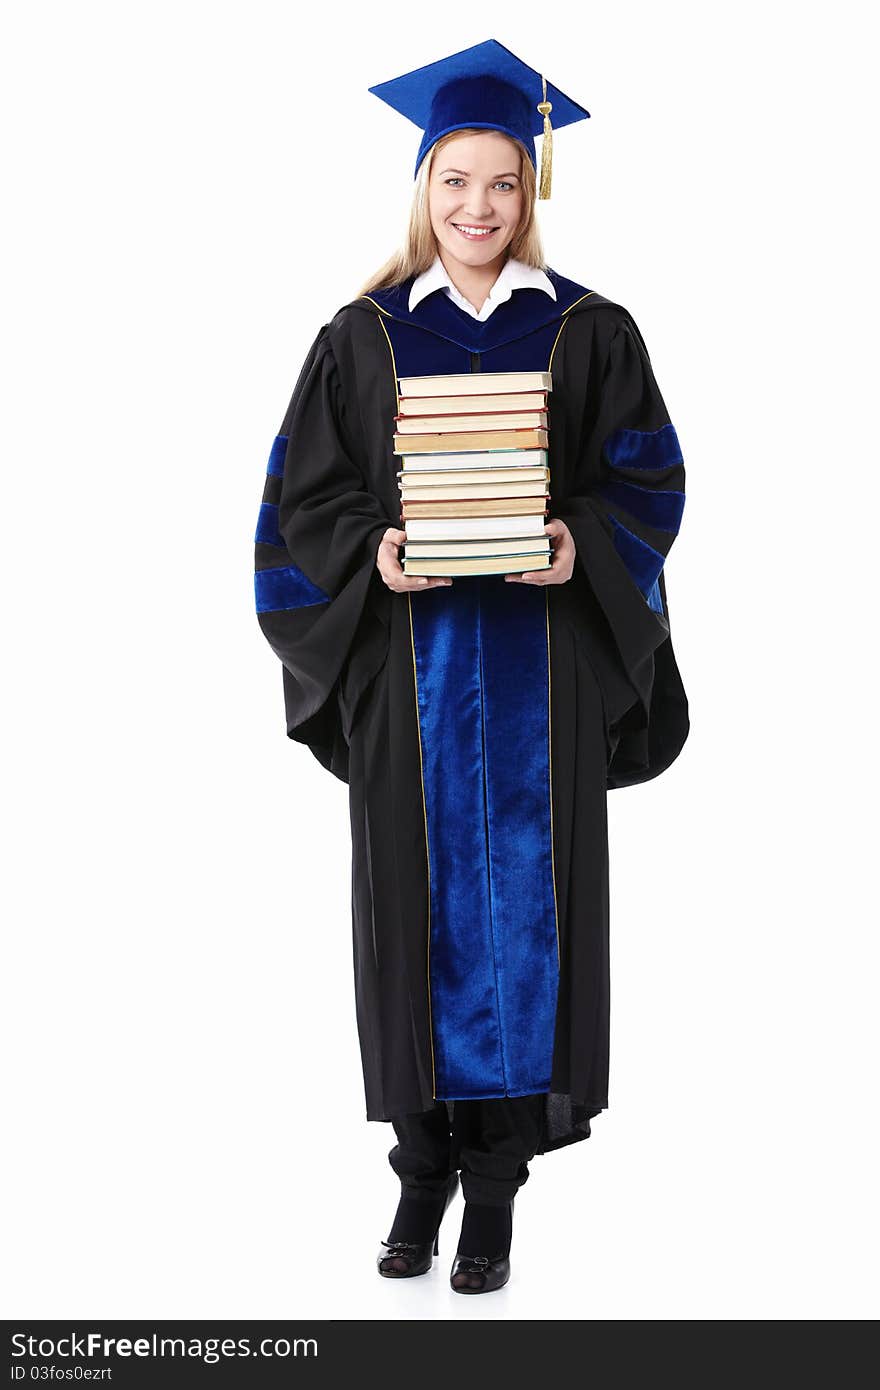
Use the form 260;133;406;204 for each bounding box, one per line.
254;270;688;1152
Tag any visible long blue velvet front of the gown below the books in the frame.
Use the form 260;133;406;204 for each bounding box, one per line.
410;575;559;1099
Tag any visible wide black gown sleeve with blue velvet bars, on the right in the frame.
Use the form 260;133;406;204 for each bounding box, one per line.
552;316;687;787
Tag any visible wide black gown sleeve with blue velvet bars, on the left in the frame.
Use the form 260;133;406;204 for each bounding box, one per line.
254;324;399;781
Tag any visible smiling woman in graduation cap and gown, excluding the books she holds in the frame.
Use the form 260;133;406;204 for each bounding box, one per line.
256;40;688;1293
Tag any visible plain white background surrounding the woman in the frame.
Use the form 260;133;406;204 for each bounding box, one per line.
0;0;879;1319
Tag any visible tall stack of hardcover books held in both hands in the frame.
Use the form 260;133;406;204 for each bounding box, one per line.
395;371;552;575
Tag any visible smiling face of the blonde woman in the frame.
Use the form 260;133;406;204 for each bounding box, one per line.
428;131;523;268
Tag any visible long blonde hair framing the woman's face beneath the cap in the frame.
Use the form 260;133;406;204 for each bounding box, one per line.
356;128;548;299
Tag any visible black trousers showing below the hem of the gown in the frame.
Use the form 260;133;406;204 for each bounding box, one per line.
388;1094;545;1207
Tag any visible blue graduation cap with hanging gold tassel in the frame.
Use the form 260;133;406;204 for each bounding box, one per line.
368;39;589;197
